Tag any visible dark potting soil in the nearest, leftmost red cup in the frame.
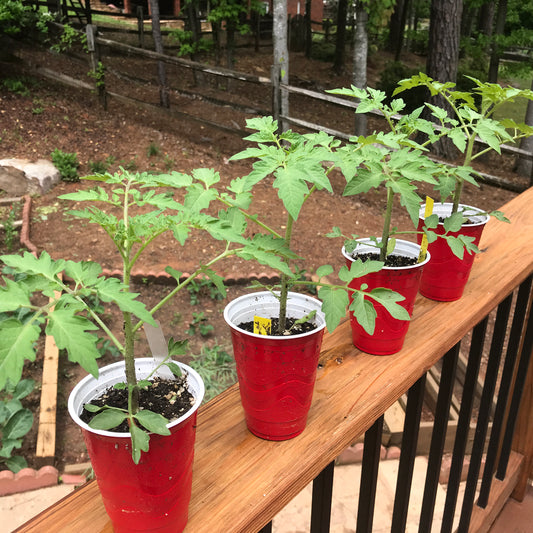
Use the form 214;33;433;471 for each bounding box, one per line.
80;376;195;433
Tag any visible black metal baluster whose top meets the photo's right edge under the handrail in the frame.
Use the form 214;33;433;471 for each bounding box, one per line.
477;277;532;508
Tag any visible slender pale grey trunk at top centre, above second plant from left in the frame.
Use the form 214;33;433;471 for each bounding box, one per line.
273;0;289;131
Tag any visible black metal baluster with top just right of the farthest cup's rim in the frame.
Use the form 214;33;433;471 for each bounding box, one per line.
441;317;488;533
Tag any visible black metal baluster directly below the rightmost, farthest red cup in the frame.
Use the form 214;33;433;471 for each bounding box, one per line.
418;343;461;533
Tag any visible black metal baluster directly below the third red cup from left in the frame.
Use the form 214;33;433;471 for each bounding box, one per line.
356;415;385;533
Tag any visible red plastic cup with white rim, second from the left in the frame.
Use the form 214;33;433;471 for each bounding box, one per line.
224;291;325;441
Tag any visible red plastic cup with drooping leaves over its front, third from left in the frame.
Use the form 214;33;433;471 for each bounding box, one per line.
342;239;429;355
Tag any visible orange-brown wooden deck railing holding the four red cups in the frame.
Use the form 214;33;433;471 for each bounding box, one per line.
18;189;533;533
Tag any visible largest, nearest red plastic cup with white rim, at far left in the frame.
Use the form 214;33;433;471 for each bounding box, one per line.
69;358;204;533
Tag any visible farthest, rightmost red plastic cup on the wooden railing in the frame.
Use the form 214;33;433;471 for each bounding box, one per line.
418;203;490;302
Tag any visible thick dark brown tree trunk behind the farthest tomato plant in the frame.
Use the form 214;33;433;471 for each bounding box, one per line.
426;0;463;159
